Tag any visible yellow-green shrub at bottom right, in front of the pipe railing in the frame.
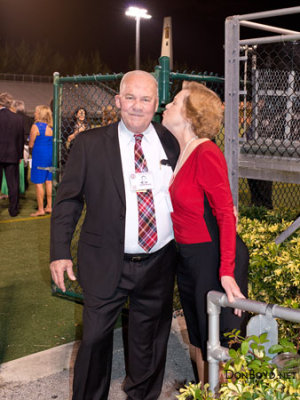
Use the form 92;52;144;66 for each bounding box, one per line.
177;331;300;400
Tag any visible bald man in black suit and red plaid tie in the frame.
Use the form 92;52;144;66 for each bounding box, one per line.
50;71;179;400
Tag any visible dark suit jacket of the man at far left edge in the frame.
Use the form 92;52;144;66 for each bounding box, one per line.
0;108;24;163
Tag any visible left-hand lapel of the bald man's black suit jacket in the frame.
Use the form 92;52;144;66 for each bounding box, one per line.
105;122;126;205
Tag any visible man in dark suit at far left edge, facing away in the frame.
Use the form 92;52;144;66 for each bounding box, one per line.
0;93;24;217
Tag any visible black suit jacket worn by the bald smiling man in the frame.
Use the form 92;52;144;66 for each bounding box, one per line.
50;123;179;298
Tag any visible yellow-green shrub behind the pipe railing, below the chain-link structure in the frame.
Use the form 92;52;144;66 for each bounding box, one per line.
238;207;300;344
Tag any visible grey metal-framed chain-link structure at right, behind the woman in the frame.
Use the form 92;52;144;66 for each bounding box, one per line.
225;7;300;209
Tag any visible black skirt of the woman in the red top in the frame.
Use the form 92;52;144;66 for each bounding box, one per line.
177;234;249;360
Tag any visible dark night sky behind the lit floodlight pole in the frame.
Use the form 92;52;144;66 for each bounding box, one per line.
0;0;300;74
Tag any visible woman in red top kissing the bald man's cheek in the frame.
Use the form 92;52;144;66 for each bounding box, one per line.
163;82;248;378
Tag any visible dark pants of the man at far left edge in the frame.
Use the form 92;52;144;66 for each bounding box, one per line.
0;162;19;217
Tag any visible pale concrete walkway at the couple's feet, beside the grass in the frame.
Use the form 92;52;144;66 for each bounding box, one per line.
0;317;194;400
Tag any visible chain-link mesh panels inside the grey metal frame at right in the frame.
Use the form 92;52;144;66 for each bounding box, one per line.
239;41;300;208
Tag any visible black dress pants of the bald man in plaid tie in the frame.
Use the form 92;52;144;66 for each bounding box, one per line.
73;242;177;400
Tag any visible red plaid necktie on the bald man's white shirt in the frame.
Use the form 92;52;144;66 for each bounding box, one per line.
134;134;157;252
